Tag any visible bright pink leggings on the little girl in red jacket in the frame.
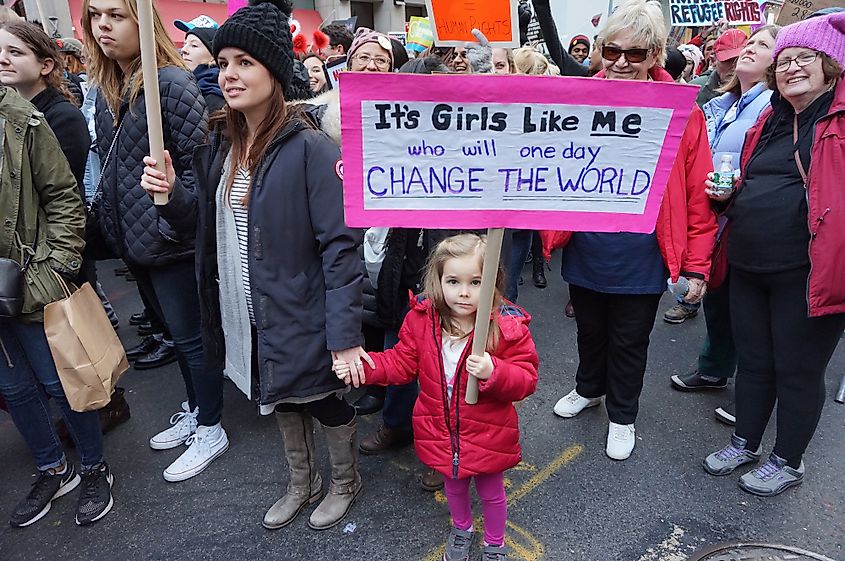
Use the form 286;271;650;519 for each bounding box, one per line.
443;472;508;545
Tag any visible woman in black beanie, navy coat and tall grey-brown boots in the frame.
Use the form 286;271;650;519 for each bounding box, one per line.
141;0;363;530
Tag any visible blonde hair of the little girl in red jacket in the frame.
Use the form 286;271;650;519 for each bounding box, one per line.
423;234;505;351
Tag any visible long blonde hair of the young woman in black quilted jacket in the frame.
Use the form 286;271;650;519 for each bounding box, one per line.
81;0;188;117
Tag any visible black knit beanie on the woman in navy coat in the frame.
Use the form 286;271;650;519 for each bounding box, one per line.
212;0;295;95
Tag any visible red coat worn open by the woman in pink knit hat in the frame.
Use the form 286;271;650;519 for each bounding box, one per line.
720;79;845;317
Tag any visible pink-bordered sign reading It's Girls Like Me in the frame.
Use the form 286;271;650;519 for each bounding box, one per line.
340;72;703;232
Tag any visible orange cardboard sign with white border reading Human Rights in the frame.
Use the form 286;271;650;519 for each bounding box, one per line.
426;0;519;48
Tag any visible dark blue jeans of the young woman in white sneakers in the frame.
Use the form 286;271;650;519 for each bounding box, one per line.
130;260;223;427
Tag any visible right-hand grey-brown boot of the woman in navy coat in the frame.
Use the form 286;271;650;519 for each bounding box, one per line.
308;419;361;530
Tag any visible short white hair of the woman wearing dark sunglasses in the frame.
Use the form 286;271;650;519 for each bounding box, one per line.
597;0;669;66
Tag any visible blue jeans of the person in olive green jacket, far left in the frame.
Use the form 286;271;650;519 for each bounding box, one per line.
0;320;103;471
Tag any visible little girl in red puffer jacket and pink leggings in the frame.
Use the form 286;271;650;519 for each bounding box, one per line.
334;234;538;561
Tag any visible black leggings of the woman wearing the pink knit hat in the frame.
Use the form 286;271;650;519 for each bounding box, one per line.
730;267;845;468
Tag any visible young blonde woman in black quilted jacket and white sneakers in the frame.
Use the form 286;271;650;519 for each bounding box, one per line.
82;0;224;482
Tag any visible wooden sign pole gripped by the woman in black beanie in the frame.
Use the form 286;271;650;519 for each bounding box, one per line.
138;0;169;205
